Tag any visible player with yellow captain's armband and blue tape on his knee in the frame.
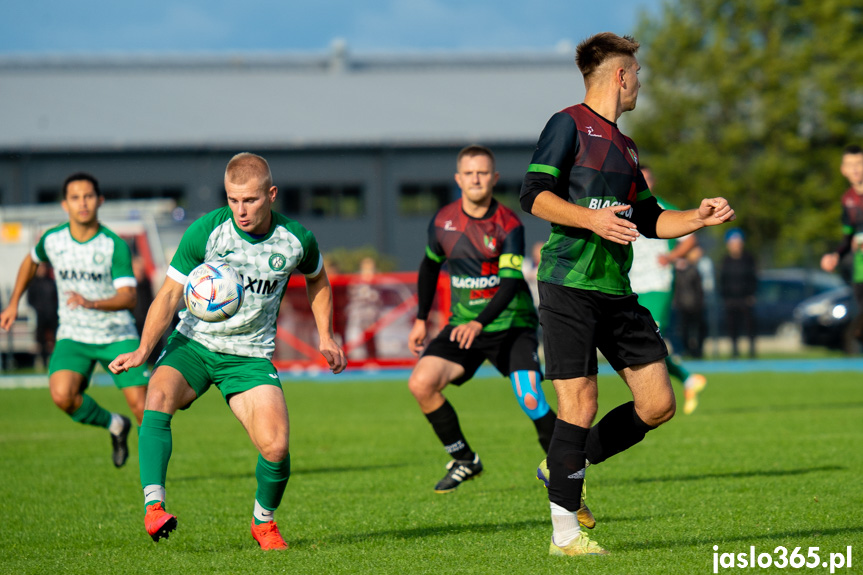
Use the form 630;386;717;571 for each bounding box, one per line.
408;146;556;493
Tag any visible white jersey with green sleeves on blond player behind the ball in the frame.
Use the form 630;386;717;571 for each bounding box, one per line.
168;206;323;359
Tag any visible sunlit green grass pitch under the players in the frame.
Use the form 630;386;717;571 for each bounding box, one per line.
0;373;863;575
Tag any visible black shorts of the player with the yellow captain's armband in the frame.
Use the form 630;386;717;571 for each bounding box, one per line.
423;325;542;385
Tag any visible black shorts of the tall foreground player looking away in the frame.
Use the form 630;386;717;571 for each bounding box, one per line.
539;282;668;379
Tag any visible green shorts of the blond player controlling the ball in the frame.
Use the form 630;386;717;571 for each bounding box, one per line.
156;331;282;409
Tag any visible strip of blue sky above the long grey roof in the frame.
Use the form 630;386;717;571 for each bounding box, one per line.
0;0;661;55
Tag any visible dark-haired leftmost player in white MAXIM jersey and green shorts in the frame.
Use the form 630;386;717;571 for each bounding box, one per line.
0;172;147;467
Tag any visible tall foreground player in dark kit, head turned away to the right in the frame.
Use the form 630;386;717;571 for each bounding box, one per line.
521;32;734;555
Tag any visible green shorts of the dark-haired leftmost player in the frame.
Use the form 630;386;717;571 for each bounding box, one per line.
48;338;150;391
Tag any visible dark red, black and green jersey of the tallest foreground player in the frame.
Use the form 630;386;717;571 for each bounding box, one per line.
521;104;661;295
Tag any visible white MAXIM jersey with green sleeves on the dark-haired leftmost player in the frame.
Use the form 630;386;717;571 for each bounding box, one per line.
30;222;138;344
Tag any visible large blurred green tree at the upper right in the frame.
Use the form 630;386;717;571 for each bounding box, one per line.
625;0;863;265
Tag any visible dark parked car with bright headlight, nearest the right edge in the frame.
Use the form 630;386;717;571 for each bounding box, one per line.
794;286;857;352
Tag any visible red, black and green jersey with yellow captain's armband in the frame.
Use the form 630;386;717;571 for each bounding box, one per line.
426;199;538;332
